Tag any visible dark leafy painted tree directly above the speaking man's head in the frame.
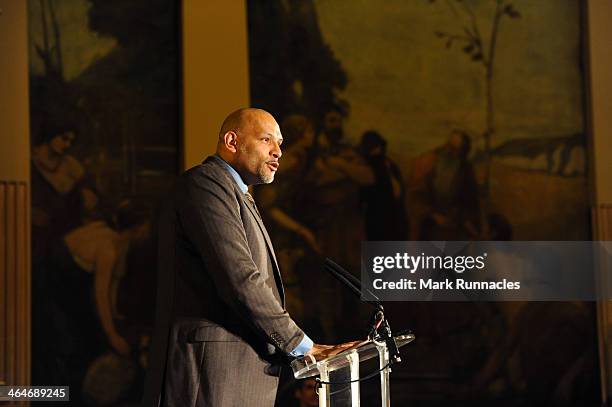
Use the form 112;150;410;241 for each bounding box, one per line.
247;0;348;119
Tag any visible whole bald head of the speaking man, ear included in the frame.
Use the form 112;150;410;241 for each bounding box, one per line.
217;108;283;184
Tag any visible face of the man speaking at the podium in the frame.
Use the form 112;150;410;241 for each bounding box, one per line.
235;114;283;185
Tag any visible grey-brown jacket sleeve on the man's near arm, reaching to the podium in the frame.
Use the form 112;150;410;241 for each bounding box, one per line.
177;174;304;353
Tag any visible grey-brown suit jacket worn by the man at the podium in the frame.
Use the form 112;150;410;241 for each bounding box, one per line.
143;157;304;407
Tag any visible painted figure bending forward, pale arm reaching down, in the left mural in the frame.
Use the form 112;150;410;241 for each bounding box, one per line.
37;201;150;400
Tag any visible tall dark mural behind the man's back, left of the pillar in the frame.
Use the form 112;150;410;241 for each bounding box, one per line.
28;0;180;406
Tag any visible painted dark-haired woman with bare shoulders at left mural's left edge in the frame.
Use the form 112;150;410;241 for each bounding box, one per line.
30;118;98;402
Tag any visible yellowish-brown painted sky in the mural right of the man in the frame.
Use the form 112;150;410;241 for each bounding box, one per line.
315;0;583;157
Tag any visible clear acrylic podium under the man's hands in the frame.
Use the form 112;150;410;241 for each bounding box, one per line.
291;334;414;407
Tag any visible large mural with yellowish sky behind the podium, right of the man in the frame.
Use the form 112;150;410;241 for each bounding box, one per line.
247;0;599;406
